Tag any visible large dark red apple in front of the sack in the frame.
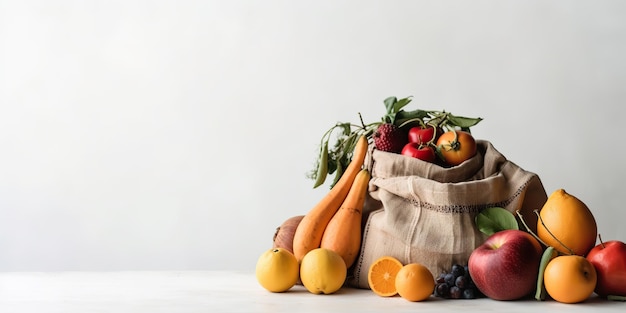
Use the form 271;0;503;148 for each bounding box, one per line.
468;230;543;300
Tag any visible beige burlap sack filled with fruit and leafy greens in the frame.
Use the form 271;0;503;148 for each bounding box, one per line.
310;97;547;288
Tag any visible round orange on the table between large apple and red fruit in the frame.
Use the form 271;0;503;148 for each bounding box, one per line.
543;255;598;303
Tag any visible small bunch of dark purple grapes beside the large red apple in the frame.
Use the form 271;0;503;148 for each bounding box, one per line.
433;264;484;299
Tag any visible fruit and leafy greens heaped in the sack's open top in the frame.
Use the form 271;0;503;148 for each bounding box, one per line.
309;97;482;188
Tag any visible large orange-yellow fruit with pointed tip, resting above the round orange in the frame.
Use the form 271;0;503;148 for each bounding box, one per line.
537;189;598;256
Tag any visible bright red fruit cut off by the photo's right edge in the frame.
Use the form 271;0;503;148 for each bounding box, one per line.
587;240;626;297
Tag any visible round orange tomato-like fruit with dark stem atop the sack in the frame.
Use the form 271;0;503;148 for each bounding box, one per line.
437;130;476;166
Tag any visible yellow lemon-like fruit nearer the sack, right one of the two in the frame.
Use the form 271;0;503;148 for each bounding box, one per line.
300;248;348;294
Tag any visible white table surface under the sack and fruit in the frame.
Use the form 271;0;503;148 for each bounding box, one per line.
0;271;626;313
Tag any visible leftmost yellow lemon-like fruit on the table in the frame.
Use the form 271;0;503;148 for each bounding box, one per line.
256;248;299;292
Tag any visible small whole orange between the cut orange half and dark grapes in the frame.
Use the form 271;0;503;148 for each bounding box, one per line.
396;263;435;302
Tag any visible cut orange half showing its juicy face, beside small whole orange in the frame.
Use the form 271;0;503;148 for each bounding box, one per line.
367;256;402;297
